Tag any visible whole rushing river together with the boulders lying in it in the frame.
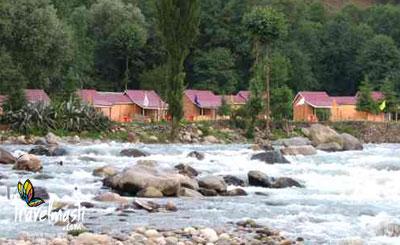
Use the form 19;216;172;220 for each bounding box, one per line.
0;130;400;244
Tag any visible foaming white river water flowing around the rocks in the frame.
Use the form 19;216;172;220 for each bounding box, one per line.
0;143;400;244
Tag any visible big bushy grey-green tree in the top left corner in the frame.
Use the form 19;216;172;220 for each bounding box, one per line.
0;0;71;88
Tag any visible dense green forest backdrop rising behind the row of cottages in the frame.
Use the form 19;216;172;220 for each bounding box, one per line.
0;0;400;98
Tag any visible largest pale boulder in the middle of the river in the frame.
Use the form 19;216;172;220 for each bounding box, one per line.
103;165;185;196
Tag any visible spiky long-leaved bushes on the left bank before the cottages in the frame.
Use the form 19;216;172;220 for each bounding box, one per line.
1;97;111;134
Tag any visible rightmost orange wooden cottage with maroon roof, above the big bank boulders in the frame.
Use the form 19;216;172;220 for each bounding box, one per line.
293;91;385;122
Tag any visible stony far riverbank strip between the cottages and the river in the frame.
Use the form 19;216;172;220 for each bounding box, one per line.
0;121;400;144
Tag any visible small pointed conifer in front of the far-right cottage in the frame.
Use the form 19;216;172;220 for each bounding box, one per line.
357;77;379;114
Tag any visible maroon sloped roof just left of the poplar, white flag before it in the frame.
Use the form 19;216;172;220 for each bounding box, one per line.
125;90;168;109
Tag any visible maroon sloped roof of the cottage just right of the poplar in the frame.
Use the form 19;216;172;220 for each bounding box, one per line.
185;89;221;109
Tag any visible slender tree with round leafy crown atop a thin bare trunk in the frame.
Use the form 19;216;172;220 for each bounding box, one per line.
245;7;288;131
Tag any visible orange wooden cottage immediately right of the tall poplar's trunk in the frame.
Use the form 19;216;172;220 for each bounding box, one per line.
183;90;221;121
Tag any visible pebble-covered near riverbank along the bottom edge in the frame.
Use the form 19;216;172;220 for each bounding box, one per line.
0;220;296;245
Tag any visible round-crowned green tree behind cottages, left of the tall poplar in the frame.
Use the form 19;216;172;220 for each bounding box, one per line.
89;0;147;90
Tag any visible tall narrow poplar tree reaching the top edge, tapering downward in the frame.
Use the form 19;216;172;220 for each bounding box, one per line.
157;0;200;139
